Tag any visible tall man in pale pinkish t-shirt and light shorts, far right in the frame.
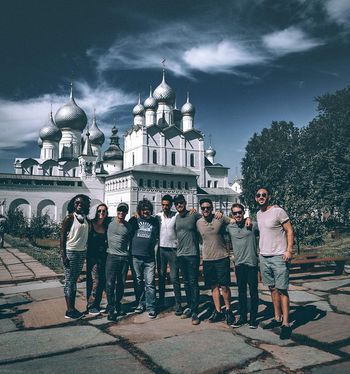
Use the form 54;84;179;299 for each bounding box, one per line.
255;187;294;339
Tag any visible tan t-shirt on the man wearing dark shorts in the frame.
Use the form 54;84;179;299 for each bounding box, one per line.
197;216;230;261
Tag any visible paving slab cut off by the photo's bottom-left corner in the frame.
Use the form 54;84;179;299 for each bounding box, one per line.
0;345;152;374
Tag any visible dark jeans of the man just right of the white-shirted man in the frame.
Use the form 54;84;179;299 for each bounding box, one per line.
177;256;199;313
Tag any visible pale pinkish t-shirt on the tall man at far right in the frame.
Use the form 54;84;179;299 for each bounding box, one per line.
256;206;289;256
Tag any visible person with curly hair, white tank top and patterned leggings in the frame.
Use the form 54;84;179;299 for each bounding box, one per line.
60;194;90;319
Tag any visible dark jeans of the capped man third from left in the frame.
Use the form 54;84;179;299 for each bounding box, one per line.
106;253;129;313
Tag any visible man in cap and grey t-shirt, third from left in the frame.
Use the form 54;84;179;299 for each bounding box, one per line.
106;203;131;321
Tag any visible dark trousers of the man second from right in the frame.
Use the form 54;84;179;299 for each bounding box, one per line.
235;264;259;321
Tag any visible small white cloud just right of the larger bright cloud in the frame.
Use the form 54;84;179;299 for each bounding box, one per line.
262;26;323;56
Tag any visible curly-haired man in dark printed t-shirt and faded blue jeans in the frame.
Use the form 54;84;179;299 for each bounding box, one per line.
129;199;159;319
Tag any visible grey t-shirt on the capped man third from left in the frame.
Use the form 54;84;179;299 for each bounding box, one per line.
107;218;131;256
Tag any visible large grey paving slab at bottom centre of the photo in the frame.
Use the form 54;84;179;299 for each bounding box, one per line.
137;330;262;374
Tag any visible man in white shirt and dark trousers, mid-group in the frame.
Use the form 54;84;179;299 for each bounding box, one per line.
156;195;182;316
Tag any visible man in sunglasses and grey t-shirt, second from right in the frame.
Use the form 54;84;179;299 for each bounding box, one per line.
226;203;259;329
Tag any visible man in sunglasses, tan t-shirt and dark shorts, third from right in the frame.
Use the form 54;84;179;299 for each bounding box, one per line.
197;198;235;326
